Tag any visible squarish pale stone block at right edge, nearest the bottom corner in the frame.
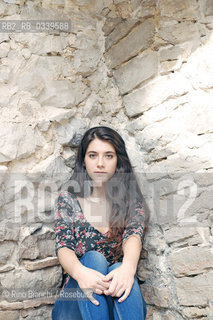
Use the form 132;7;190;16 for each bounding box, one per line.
175;270;213;306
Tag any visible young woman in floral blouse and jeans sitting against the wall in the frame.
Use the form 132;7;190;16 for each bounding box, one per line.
52;127;147;320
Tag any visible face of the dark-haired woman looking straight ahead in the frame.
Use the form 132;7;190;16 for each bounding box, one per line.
84;138;117;186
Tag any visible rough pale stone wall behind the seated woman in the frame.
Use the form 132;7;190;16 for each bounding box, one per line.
0;0;213;320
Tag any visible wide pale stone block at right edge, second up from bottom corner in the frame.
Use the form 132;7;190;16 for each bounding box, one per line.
169;247;213;277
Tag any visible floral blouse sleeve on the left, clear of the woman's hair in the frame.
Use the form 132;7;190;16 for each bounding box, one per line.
55;192;76;254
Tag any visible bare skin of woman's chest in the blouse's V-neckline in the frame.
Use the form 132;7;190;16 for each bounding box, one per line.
78;197;111;233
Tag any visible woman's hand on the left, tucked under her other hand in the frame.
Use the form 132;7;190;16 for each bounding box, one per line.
76;265;110;305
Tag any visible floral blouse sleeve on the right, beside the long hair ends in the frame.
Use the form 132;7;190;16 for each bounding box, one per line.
122;200;146;243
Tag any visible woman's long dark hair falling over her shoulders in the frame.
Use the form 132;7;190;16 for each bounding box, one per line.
68;126;148;255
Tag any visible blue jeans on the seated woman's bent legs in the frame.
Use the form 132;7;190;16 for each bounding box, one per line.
52;251;146;320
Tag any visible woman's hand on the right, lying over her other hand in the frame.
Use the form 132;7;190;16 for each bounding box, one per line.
104;264;135;302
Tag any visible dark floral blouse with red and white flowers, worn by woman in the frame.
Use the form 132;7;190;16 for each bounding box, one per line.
55;191;145;283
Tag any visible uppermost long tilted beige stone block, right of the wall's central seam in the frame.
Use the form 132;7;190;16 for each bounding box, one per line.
105;20;155;68
